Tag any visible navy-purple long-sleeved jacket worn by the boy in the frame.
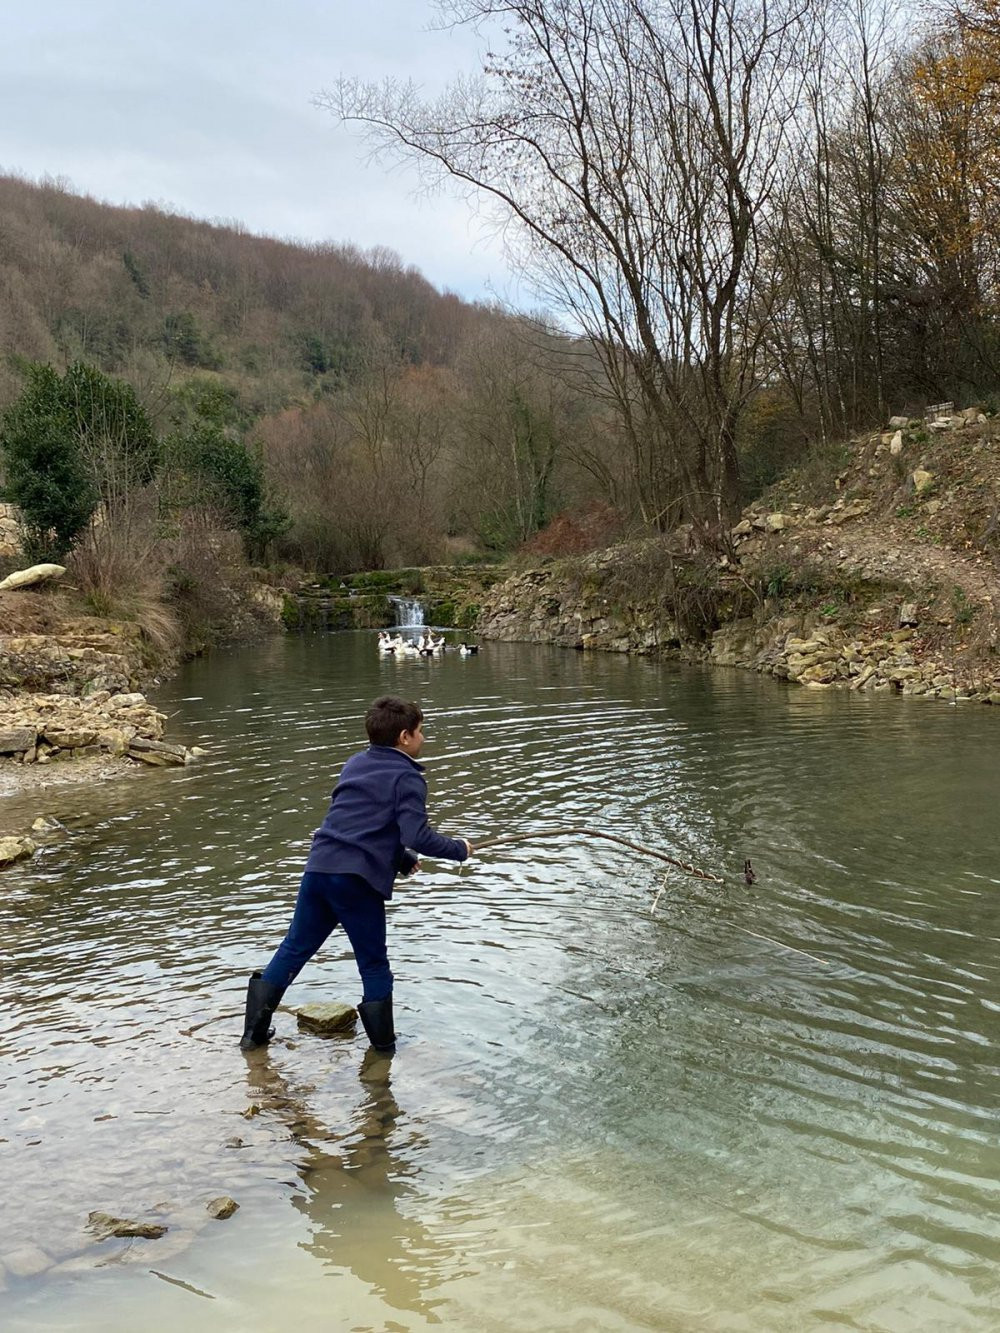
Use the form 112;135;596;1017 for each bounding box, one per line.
305;745;467;898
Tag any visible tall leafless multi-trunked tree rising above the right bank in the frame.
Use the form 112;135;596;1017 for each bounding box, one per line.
329;0;804;533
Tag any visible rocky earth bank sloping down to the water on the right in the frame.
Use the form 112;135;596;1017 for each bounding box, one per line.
480;405;1000;704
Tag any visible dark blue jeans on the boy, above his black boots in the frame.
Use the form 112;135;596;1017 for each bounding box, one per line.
264;870;392;1002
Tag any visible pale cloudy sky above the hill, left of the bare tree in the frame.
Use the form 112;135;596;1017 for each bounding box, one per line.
0;0;513;299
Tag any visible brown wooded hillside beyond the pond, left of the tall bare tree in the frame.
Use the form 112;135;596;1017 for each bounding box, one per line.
0;176;602;571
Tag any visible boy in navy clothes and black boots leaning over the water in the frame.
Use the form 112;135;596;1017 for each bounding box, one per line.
240;694;472;1050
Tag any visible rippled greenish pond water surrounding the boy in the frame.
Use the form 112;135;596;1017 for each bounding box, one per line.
0;633;1000;1333
